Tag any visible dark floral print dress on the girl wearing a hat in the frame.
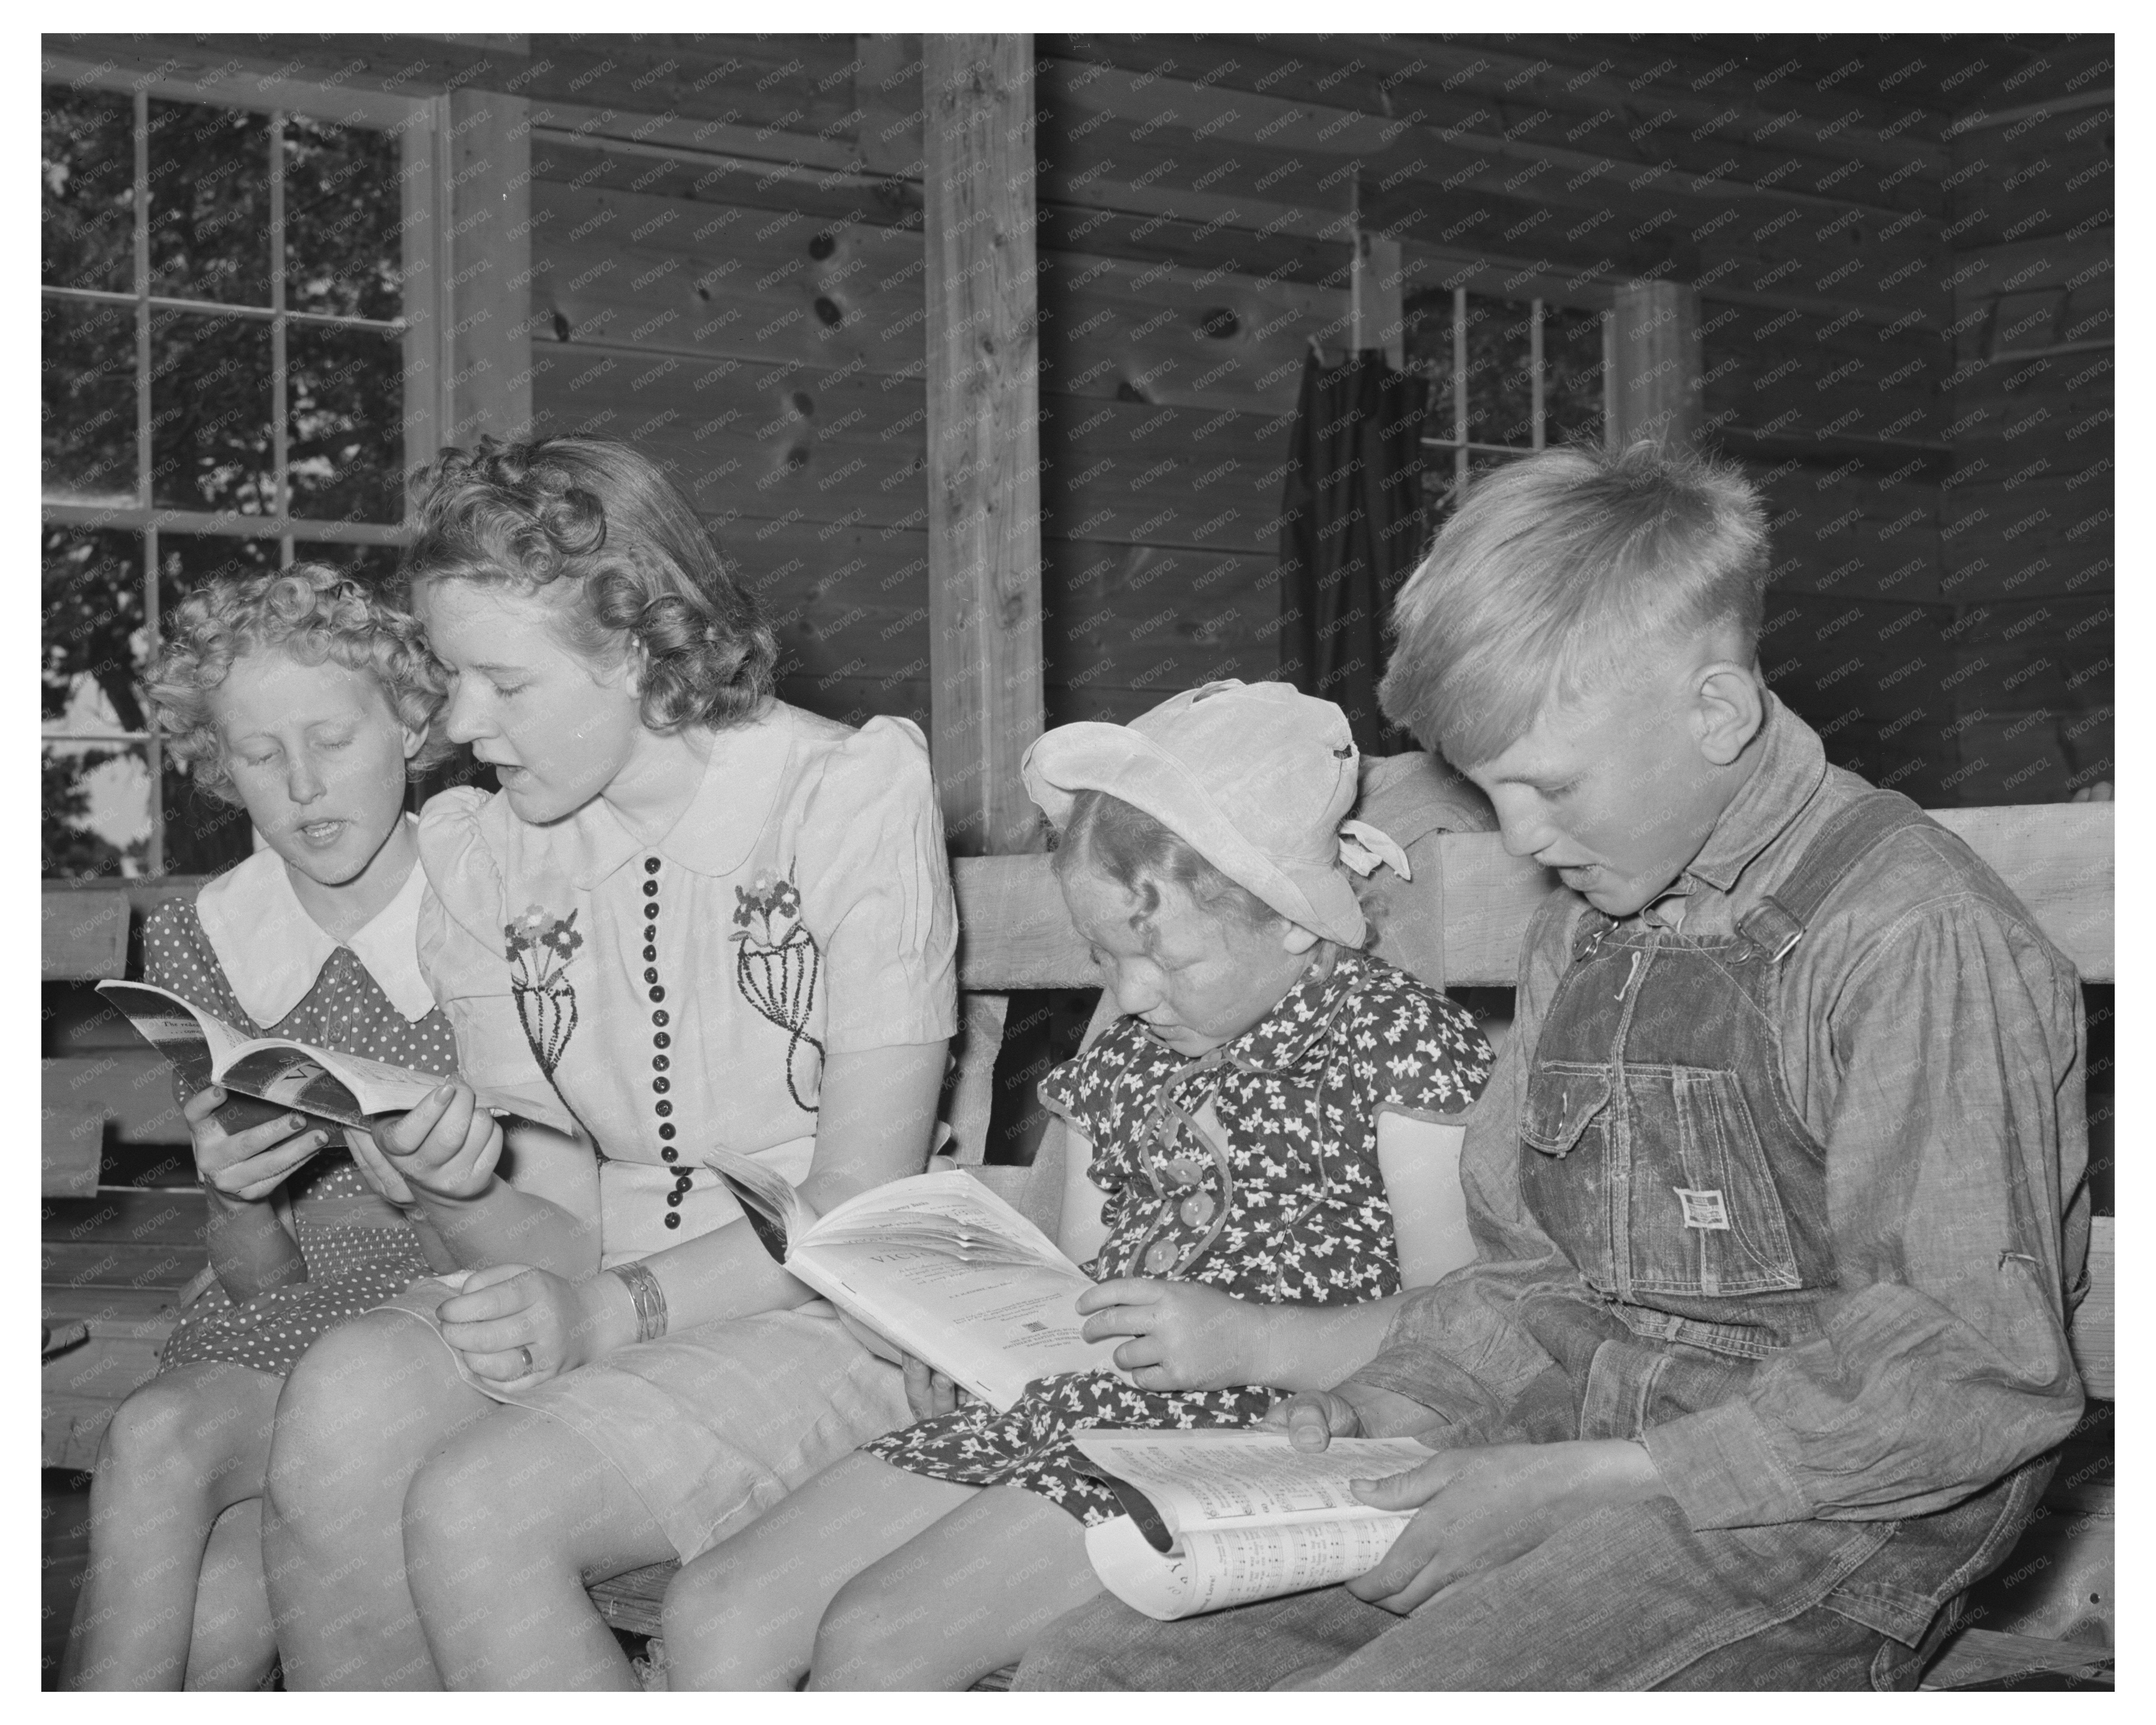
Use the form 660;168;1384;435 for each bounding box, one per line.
863;953;1492;1527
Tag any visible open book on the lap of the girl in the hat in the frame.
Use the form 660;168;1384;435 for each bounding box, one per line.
705;1149;1117;1412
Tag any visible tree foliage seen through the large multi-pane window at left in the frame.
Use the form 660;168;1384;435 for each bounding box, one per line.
41;80;405;876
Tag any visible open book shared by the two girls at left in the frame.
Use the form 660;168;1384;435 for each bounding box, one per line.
97;983;442;1132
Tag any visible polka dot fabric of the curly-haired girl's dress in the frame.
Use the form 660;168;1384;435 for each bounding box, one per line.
142;899;457;1378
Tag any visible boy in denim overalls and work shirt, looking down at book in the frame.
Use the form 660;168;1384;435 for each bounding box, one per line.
1020;446;2089;1688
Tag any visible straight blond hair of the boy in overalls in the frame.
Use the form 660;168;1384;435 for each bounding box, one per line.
1378;440;1768;768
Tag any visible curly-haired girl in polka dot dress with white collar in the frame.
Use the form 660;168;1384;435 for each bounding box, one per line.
65;563;457;1688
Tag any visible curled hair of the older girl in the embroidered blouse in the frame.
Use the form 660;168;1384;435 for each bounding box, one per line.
401;438;778;733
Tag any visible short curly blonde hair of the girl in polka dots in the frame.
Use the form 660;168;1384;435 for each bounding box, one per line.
142;563;453;802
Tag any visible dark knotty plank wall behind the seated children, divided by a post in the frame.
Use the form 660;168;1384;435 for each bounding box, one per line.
67;34;2111;802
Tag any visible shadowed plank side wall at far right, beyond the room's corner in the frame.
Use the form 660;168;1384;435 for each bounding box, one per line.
1940;87;2117;802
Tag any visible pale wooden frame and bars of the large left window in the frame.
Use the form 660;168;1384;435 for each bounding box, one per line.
39;54;451;880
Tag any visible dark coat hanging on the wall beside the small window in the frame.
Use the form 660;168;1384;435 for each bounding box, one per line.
1281;347;1430;755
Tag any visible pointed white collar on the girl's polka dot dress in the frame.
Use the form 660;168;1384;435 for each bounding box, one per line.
194;815;433;1024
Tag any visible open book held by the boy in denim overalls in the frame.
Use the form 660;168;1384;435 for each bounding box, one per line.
1072;1425;1432;1619
